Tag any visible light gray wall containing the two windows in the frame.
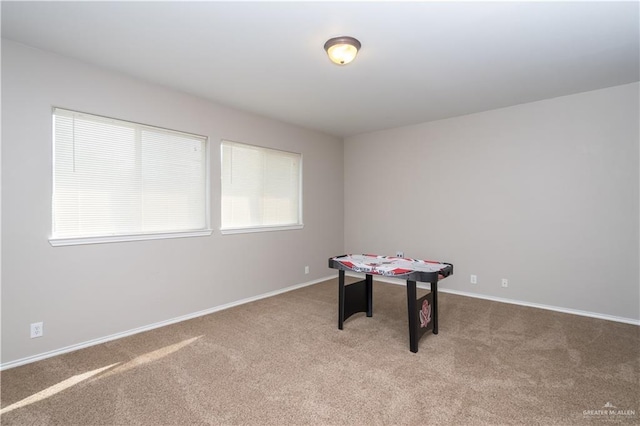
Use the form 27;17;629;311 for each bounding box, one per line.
2;40;344;364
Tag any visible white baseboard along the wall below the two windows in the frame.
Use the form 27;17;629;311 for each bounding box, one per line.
0;276;335;371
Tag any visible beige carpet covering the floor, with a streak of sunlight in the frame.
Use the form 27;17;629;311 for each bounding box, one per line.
0;280;640;425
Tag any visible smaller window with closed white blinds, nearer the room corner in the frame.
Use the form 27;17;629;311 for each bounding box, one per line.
221;141;302;233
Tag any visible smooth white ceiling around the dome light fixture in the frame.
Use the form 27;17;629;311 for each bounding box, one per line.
2;1;640;136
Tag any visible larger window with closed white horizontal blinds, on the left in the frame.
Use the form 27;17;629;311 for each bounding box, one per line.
50;108;211;245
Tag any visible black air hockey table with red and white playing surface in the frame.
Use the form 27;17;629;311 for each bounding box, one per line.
329;254;453;353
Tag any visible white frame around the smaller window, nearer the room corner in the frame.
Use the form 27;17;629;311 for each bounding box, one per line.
219;139;304;235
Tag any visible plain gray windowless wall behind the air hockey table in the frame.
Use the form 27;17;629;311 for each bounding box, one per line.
344;83;640;321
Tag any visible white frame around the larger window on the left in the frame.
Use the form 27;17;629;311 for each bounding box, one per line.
48;106;213;247
